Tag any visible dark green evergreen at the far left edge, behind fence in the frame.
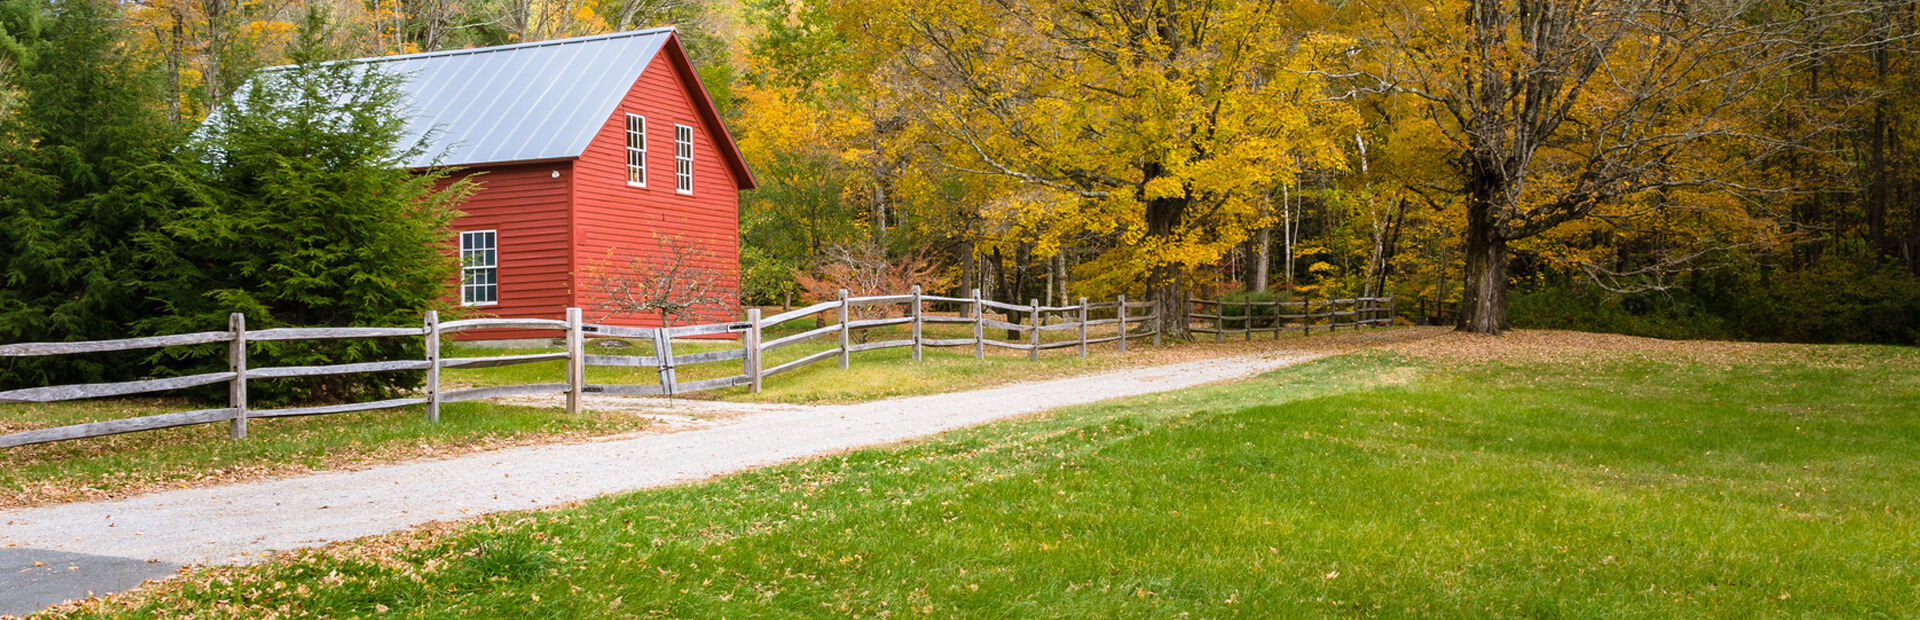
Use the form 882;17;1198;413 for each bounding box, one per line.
0;0;169;384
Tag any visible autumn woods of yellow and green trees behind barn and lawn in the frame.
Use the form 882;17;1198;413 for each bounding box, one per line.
0;0;1920;387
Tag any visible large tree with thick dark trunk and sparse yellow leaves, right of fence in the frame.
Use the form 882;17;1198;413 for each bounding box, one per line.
1354;0;1876;334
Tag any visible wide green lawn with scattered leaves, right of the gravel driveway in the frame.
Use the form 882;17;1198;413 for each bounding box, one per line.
48;341;1920;618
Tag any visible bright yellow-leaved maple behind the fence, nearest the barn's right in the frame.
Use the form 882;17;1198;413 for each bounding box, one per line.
837;0;1354;332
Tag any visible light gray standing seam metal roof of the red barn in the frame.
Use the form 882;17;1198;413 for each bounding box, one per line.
337;27;674;167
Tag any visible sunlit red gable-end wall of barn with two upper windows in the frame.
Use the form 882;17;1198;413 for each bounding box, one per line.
574;44;739;326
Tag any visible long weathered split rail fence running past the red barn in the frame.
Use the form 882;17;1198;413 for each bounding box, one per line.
0;286;1162;447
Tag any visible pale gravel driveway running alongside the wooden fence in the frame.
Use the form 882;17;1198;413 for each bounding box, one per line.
0;353;1323;564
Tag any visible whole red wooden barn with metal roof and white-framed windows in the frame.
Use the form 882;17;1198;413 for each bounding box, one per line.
365;27;755;338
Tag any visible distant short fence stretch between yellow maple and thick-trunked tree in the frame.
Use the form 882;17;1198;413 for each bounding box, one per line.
1187;296;1394;342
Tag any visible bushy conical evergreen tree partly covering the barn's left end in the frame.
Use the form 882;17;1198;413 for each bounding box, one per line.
142;13;468;399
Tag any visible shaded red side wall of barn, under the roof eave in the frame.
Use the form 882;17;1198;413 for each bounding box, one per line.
449;161;574;340
